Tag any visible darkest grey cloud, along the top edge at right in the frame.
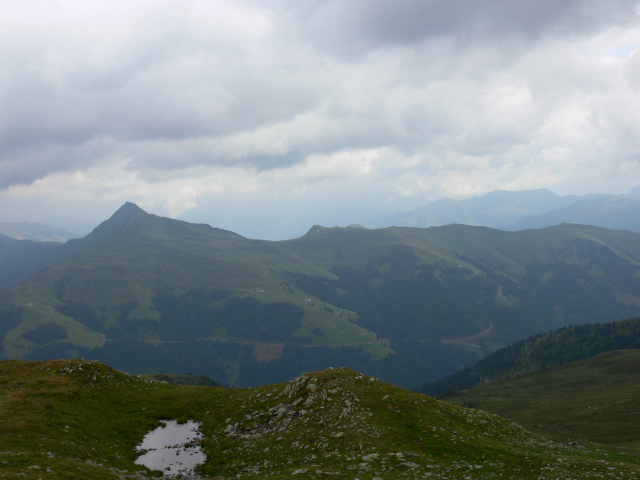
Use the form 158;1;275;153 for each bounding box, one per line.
289;0;638;54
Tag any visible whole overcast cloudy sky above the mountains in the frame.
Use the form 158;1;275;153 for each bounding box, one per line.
0;0;640;239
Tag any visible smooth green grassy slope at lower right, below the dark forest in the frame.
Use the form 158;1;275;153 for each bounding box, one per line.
445;350;640;455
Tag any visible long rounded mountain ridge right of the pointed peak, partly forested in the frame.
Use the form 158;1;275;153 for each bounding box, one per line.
288;225;640;349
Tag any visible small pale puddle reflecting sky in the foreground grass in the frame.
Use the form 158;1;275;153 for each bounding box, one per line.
135;420;207;477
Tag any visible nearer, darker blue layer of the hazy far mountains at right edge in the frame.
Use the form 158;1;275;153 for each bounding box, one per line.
506;195;640;232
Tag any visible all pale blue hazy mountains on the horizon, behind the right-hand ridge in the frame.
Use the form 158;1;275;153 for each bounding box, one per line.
364;186;640;232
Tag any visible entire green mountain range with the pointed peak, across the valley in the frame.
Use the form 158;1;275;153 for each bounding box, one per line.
0;204;640;386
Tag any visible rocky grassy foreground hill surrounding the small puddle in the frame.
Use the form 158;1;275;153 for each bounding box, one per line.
0;360;640;480
